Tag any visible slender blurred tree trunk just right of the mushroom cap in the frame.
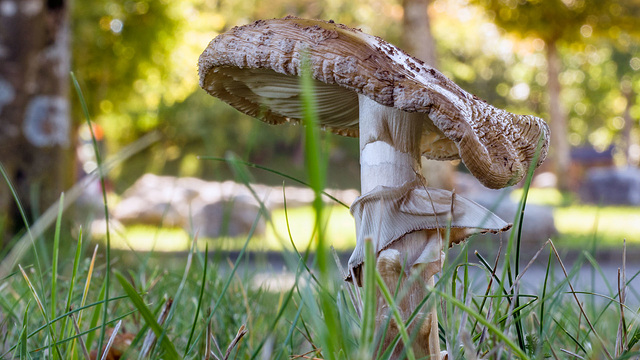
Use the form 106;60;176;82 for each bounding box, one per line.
547;41;571;191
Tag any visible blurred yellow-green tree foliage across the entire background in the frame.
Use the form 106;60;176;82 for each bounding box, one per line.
72;0;640;190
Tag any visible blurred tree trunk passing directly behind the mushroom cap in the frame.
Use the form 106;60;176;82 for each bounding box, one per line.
402;0;454;190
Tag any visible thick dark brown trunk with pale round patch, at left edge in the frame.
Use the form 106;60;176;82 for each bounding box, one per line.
0;0;73;242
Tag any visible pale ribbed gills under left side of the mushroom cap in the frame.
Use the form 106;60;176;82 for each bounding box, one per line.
218;67;358;128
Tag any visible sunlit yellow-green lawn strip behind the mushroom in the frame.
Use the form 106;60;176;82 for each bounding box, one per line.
112;200;640;251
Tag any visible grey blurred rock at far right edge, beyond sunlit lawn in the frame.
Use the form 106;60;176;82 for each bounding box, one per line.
580;167;640;206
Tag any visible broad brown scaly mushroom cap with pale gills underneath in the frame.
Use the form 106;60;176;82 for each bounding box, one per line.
199;17;549;188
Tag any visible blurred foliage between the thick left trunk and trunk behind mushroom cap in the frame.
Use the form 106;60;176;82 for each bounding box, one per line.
73;0;402;190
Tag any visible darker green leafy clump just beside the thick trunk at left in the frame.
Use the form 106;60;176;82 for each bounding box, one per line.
73;0;185;141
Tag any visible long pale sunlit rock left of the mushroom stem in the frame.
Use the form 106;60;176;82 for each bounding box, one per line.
113;174;359;237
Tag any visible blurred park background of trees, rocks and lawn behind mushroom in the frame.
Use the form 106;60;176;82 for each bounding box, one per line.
0;0;640;255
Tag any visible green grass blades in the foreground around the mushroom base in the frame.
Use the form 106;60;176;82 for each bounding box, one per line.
0;200;638;359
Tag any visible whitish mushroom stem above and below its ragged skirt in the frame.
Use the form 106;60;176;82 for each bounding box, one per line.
359;95;442;359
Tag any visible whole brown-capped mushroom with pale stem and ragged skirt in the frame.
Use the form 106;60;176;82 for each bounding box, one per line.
199;17;549;359
